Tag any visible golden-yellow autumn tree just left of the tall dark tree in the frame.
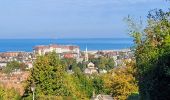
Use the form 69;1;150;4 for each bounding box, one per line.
103;64;138;100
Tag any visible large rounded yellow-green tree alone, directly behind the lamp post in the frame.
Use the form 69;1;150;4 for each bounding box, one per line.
23;52;70;97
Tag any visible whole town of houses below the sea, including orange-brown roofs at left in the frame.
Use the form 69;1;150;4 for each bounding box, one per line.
0;44;133;95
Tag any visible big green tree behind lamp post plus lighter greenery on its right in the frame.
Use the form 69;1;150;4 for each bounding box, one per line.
24;52;93;100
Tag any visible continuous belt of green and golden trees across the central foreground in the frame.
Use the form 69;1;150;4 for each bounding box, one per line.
20;52;138;100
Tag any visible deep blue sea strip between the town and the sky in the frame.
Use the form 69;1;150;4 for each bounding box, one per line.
0;38;133;52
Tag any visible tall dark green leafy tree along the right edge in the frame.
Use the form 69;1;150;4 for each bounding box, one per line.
127;10;170;100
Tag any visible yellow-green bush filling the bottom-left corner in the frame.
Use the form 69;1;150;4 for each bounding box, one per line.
0;87;21;100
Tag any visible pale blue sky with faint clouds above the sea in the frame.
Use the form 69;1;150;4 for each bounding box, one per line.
0;0;168;39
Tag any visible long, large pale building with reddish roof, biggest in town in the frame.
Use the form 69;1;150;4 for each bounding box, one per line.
34;44;80;58
